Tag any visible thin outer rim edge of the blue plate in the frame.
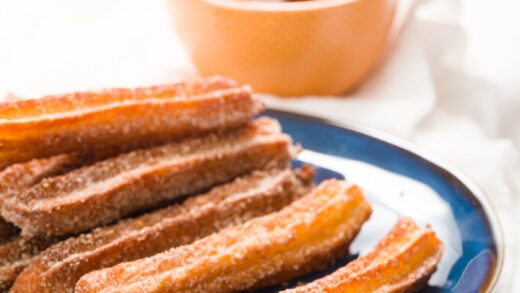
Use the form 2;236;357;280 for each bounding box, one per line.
265;106;506;292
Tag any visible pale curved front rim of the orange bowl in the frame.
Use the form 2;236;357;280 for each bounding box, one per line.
201;0;364;12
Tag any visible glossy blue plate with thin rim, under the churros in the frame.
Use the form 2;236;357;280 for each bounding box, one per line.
262;110;503;292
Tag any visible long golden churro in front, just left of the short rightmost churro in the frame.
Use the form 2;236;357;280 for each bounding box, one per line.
75;180;371;293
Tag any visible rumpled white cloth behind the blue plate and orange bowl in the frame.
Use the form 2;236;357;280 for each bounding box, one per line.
0;0;520;292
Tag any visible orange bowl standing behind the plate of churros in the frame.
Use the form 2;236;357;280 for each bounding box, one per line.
168;0;396;96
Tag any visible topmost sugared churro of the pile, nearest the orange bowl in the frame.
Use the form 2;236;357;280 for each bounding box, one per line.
0;77;263;166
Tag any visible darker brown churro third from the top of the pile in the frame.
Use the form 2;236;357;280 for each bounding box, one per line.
11;167;313;293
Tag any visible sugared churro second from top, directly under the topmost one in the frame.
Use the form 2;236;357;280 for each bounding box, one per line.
1;118;293;236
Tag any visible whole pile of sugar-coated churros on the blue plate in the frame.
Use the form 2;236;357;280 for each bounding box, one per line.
0;77;442;292
